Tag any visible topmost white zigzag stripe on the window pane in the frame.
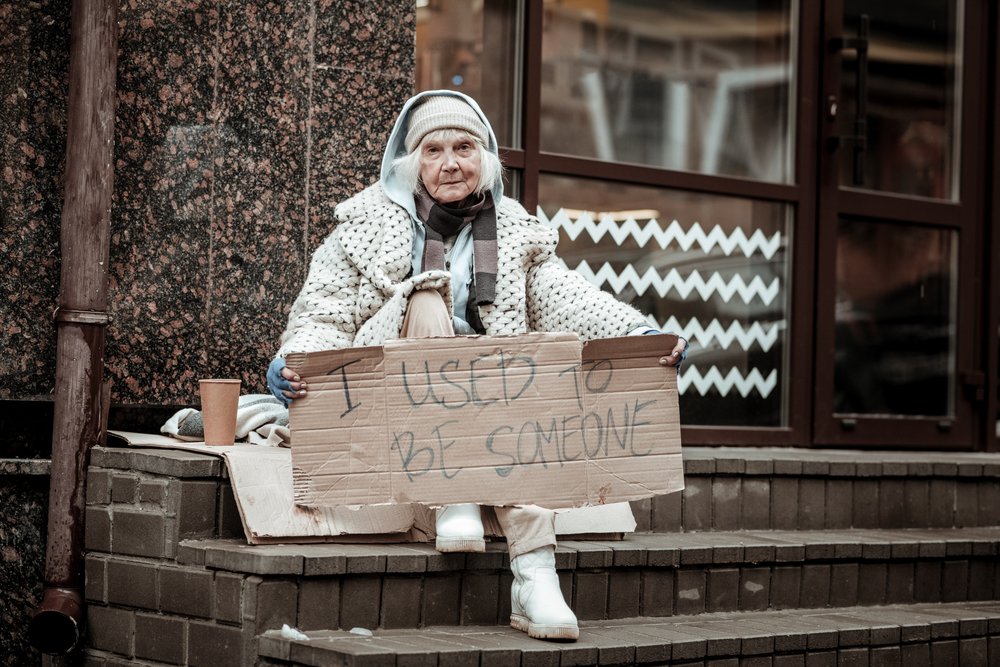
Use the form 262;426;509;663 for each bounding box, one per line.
538;207;781;259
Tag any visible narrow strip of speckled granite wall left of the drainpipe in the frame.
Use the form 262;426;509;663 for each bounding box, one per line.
0;0;69;399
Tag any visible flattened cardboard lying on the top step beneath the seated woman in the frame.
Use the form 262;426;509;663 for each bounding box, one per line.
108;431;636;544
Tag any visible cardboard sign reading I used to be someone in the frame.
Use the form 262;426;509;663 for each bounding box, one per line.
287;333;684;508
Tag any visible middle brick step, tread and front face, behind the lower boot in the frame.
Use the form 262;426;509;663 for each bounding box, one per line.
86;528;1000;639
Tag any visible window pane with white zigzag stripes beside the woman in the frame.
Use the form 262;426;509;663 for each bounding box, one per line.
538;175;790;426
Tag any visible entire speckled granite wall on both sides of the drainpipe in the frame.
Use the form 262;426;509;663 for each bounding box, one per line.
0;0;416;406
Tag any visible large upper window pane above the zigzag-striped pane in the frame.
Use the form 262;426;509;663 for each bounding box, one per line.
541;0;796;182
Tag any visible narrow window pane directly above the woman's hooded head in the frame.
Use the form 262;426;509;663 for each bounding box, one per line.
416;0;522;148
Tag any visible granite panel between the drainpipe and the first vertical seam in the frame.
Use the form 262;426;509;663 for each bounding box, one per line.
106;0;218;404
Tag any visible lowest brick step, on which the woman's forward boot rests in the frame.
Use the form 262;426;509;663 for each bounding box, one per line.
258;603;1000;667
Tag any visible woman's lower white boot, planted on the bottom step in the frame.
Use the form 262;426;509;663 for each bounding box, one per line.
510;546;580;640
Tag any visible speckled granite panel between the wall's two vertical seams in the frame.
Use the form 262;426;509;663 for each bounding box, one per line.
202;0;312;386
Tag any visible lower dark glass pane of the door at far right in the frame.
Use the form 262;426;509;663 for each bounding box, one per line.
834;219;956;416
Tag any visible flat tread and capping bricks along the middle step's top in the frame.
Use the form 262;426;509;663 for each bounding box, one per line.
170;526;1000;577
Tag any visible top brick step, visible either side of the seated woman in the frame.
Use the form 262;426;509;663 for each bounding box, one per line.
87;447;1000;558
